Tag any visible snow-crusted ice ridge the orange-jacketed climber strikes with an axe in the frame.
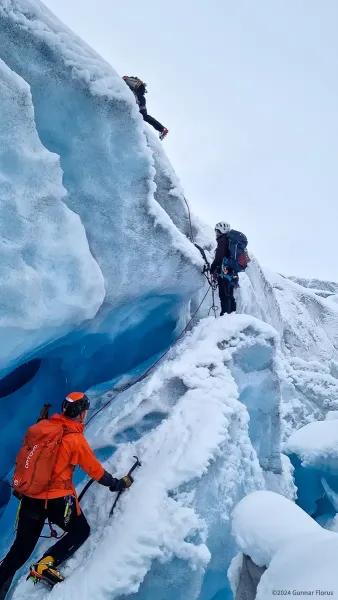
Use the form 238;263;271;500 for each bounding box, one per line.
9;315;282;600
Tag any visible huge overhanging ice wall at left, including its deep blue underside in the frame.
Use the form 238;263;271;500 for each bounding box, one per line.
0;0;205;482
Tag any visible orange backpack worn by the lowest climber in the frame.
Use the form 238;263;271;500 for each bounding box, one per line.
12;419;67;496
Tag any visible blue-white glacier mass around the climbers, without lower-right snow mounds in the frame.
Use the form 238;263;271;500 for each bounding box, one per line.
0;0;338;600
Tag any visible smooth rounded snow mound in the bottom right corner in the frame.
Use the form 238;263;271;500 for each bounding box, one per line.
230;491;338;600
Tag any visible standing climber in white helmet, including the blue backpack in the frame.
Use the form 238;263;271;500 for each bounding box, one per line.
210;221;250;317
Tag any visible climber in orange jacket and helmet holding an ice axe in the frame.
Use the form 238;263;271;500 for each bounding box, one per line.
0;392;133;600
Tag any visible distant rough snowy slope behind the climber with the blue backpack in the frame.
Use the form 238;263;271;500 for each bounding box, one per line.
239;257;338;439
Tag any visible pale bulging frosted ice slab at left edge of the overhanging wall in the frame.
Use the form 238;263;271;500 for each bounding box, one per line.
0;55;105;370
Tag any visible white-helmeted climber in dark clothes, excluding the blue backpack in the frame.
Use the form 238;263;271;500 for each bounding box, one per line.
210;222;238;317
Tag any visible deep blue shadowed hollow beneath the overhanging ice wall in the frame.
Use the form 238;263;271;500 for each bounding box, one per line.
0;296;182;528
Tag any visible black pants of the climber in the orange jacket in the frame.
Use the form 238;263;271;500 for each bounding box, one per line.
0;496;90;599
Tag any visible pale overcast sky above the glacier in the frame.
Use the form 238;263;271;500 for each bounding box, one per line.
45;0;338;281
